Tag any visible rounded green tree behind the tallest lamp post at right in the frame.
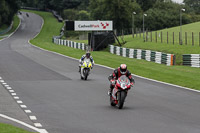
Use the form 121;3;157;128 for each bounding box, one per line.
145;2;191;30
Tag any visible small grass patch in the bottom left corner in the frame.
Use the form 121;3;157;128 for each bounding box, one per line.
0;123;35;133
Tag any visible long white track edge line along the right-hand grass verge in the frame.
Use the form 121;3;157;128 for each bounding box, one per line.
28;13;200;93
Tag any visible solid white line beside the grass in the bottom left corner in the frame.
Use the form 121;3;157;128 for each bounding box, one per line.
0;114;48;133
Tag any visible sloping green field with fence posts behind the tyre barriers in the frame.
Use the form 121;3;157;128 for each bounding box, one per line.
111;22;200;65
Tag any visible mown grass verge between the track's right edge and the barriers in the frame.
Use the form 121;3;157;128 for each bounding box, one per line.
21;11;200;90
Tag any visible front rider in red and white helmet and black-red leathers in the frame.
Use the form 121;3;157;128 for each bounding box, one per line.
108;64;135;95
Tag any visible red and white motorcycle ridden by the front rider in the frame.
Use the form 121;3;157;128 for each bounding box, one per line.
110;75;132;109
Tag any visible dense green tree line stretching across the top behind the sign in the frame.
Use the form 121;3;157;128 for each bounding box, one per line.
22;0;200;30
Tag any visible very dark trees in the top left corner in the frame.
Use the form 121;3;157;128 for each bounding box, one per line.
0;0;19;26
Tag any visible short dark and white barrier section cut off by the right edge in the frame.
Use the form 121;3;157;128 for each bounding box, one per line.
183;54;200;68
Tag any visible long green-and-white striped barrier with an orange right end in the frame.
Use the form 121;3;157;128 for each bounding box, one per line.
110;45;175;66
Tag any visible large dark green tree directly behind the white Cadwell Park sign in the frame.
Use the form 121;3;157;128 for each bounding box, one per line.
89;0;141;30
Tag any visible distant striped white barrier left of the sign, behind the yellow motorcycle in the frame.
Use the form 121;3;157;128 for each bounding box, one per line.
53;37;87;50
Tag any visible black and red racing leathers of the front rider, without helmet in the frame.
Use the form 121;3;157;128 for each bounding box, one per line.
108;68;135;95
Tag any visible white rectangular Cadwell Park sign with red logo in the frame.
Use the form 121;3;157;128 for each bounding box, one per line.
74;21;113;31
